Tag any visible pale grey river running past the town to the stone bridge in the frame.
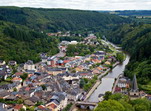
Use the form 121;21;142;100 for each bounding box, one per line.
88;54;130;102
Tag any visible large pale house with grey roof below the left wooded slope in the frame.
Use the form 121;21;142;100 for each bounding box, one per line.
24;60;36;72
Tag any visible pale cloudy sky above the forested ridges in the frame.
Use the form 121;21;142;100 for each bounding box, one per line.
0;0;151;10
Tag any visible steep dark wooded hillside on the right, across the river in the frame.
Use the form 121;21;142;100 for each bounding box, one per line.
108;24;151;93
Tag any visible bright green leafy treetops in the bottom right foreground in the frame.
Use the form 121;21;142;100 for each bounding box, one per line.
94;92;151;111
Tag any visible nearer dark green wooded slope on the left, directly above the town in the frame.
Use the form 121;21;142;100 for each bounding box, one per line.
0;21;59;63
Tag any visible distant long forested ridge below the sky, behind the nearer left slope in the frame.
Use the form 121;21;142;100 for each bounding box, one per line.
0;7;130;32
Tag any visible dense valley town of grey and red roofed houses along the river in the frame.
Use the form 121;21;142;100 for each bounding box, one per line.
0;33;149;111
